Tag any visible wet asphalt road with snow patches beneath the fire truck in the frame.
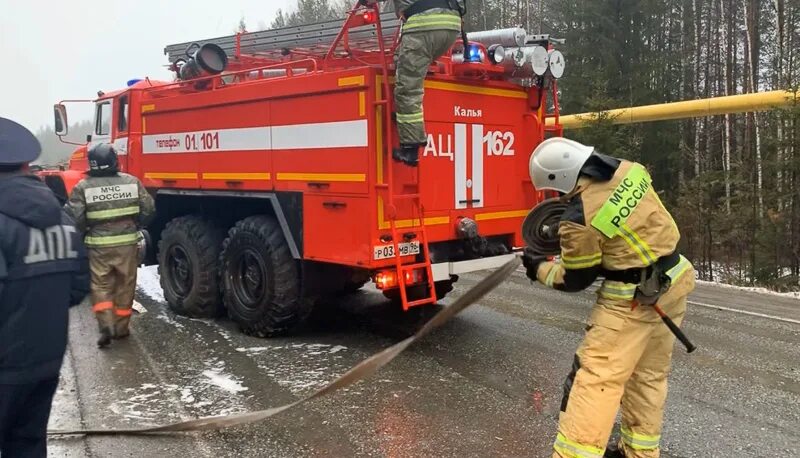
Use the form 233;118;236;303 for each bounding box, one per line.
50;273;800;457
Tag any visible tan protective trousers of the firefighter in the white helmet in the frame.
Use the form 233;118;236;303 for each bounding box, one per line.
553;267;695;458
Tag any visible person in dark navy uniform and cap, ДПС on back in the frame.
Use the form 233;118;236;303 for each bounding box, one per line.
0;118;89;458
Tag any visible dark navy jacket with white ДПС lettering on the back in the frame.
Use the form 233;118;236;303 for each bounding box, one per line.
0;174;89;385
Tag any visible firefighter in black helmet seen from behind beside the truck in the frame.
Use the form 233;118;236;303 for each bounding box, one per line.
67;144;155;348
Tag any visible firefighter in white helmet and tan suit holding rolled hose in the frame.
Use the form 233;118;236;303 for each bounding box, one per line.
523;138;695;458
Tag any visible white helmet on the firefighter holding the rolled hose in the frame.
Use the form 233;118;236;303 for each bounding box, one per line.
528;137;594;194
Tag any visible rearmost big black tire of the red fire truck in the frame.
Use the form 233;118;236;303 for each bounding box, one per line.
220;216;313;337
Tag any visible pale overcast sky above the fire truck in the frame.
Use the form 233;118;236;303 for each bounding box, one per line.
0;0;297;132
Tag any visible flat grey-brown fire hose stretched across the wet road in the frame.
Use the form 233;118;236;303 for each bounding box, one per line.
47;258;520;436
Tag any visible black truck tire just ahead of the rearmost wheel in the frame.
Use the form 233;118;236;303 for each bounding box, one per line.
158;215;224;318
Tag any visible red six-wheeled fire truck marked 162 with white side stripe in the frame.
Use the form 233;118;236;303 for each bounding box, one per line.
42;5;563;336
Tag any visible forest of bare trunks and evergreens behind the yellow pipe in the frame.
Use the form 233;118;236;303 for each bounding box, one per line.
39;0;800;290
